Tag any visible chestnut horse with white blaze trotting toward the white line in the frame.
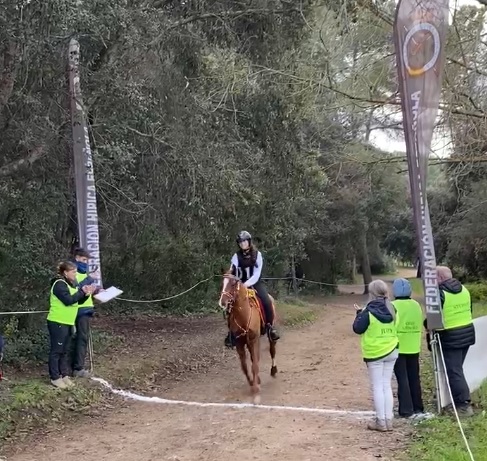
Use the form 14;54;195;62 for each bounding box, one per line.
219;273;277;402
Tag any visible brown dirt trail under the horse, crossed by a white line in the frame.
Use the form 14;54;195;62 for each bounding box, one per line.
8;296;408;461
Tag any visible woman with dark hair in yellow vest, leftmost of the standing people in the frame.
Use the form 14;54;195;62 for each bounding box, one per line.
47;261;93;389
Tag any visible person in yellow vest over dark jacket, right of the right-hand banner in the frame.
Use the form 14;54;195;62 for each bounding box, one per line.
424;266;475;416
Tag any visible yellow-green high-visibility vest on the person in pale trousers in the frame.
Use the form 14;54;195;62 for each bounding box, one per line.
361;312;398;360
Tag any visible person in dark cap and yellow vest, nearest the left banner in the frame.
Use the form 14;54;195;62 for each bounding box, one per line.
72;248;100;378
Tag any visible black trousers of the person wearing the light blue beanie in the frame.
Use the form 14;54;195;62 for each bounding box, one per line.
394;354;424;418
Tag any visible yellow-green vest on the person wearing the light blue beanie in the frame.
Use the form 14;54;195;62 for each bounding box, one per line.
392;299;423;354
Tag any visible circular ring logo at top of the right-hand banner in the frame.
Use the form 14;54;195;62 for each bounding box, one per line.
402;22;441;77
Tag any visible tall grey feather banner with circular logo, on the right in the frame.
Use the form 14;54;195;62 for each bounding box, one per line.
394;0;448;407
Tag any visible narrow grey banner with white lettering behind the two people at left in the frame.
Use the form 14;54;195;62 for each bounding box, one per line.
68;39;102;288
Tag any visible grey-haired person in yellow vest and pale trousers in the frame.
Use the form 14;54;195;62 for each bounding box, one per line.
353;280;399;432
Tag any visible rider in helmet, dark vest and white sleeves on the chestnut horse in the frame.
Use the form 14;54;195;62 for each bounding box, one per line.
225;231;279;347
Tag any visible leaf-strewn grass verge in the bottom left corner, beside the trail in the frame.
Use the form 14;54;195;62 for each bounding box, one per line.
0;377;102;446
